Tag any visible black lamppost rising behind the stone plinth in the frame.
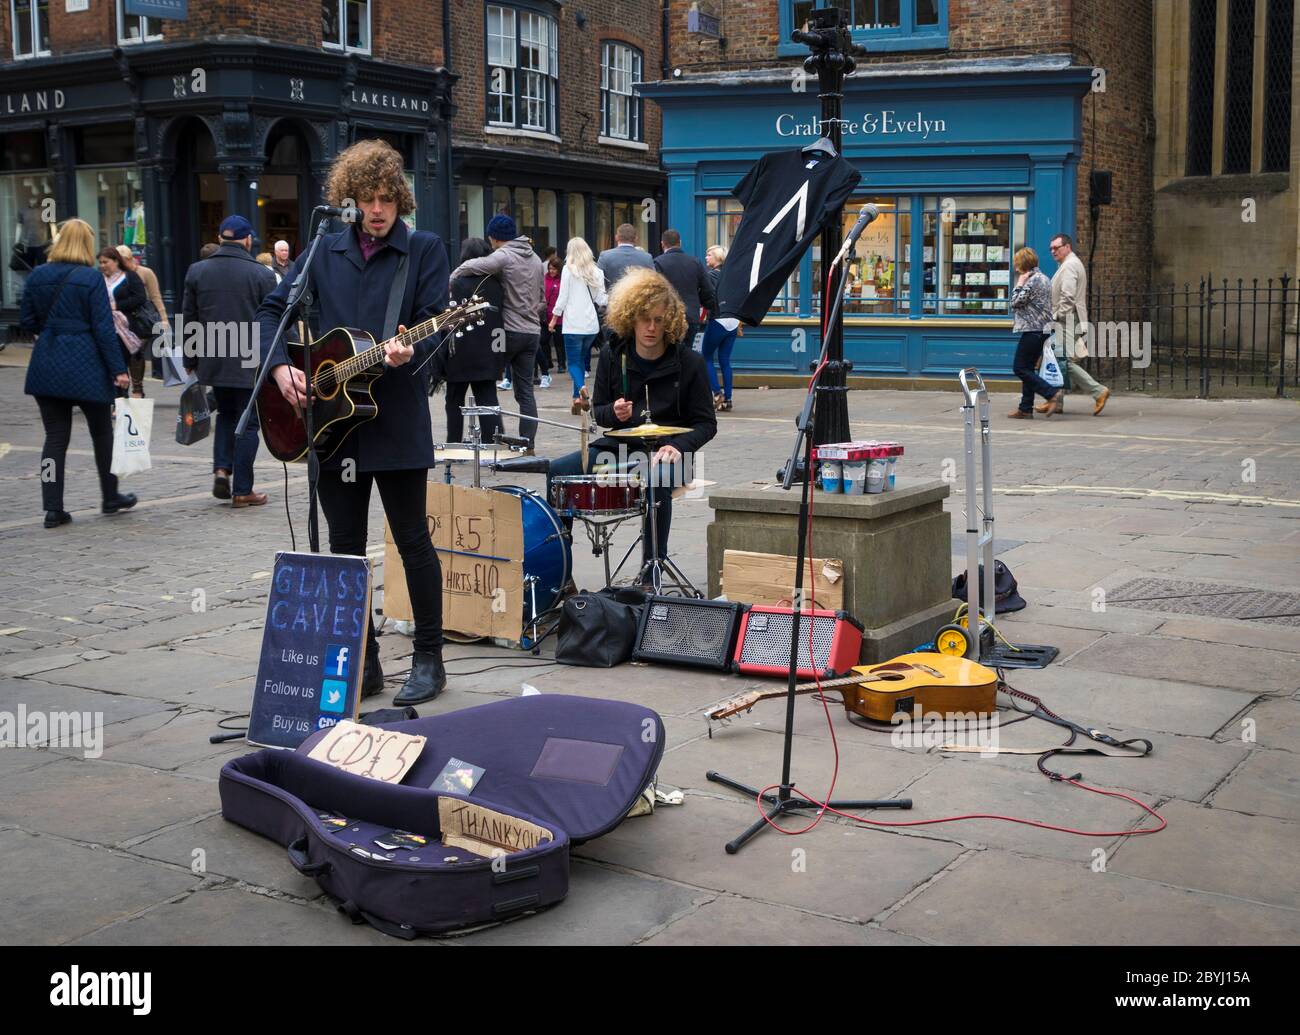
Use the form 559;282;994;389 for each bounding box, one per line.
790;8;866;446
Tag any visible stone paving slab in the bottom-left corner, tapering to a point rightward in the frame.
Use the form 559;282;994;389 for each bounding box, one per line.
0;830;200;945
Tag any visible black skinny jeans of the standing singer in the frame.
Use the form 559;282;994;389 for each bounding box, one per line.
319;468;442;657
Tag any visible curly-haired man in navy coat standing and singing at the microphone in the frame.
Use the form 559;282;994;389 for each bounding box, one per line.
257;140;449;705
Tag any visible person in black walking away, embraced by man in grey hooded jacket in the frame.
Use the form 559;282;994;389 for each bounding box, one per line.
442;237;506;442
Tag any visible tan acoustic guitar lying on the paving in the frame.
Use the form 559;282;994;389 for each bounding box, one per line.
705;654;998;723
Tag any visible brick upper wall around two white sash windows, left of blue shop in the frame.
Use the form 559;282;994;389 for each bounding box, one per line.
451;0;662;168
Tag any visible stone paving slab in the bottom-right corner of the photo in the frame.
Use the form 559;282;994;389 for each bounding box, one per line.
883;849;1300;945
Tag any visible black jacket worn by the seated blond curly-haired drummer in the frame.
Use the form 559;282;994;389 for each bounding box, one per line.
592;338;718;452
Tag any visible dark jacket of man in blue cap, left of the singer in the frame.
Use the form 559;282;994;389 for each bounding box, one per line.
177;244;276;387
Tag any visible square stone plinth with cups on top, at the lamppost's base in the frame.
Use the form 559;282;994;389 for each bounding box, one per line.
709;478;957;663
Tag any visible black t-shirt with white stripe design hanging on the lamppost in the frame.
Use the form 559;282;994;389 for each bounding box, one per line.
718;150;862;326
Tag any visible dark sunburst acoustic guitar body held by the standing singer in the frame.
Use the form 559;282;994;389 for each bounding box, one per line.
257;328;384;463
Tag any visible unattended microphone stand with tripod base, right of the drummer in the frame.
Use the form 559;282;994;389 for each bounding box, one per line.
705;215;911;856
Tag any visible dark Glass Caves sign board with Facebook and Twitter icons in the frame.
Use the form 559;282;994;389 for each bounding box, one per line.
247;553;371;749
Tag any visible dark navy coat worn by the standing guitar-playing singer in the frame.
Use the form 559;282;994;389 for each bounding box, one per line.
257;220;450;471
